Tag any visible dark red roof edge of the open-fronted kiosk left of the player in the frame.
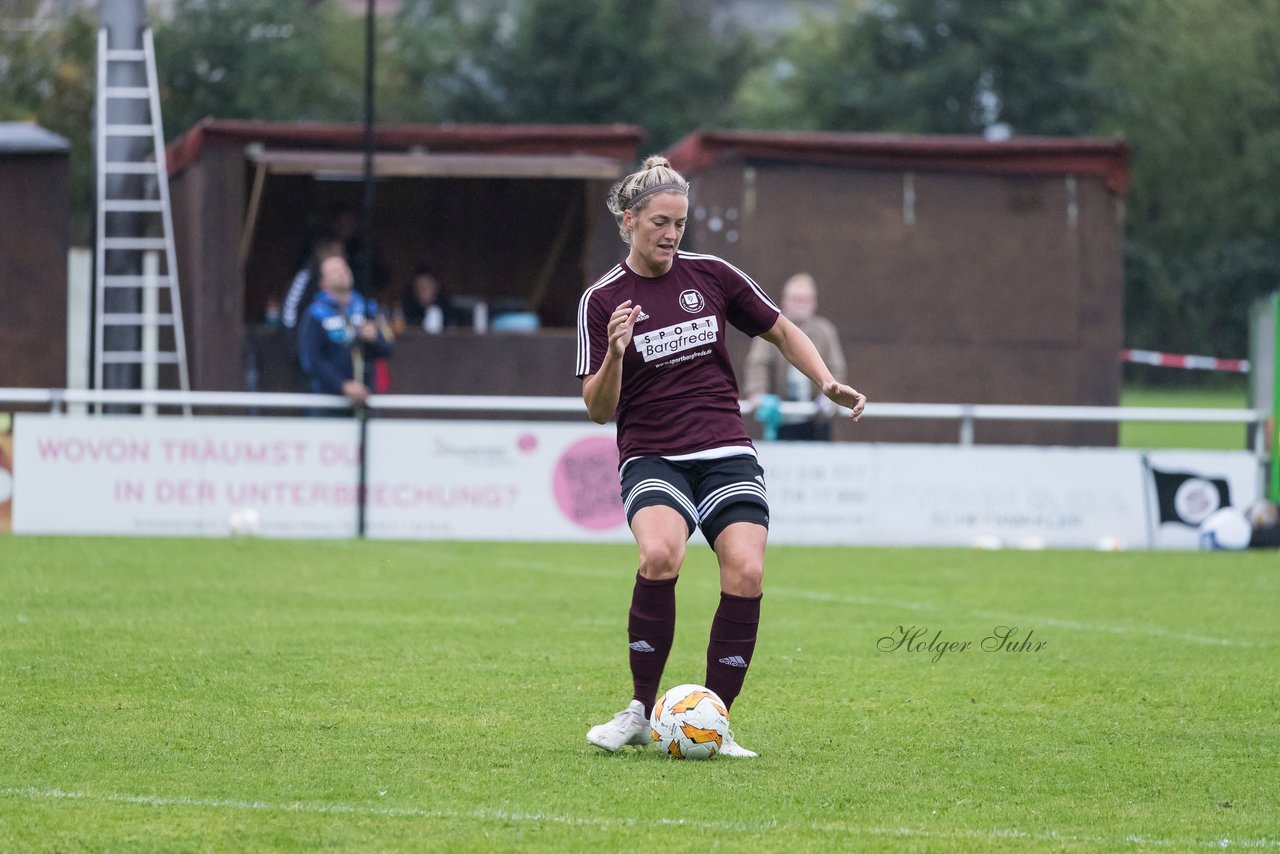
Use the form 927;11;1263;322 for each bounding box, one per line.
168;119;645;175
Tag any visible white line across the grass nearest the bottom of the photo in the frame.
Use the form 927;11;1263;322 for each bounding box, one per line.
0;787;1280;849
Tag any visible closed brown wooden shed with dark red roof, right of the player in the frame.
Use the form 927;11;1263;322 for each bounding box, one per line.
668;131;1129;444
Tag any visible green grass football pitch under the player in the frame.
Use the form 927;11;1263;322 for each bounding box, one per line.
0;536;1280;851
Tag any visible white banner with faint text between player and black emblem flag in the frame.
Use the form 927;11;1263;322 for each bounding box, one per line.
760;443;1148;548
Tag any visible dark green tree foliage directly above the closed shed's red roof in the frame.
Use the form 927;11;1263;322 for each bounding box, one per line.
737;0;1108;134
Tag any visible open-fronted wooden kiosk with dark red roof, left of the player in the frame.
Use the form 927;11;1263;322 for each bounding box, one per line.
168;119;644;394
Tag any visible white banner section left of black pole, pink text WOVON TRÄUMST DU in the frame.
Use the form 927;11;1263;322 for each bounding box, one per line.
13;414;358;538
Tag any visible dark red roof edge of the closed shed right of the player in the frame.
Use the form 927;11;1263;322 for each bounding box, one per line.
667;131;1129;195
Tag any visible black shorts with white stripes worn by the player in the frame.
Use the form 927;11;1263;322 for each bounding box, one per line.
622;455;769;545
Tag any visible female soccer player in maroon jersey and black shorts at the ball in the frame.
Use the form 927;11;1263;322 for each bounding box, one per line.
577;156;867;757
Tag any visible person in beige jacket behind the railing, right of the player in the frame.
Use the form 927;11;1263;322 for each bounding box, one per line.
742;273;845;442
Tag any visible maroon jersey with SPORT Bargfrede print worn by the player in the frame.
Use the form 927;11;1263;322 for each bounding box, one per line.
577;252;778;462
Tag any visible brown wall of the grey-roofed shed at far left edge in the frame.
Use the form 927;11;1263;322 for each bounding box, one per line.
0;152;70;388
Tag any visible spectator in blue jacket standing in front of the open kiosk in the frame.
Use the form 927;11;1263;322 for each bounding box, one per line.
298;255;392;406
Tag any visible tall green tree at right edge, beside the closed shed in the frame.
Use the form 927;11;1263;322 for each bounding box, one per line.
1103;0;1280;356
